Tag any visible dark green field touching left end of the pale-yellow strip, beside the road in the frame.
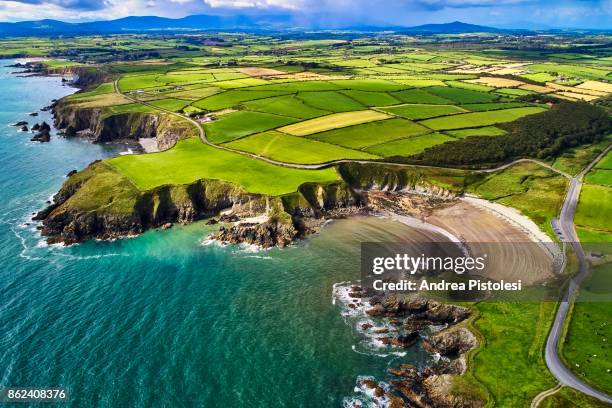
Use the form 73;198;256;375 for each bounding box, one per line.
204;111;298;143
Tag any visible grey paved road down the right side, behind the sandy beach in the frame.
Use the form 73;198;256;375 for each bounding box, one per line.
545;146;612;404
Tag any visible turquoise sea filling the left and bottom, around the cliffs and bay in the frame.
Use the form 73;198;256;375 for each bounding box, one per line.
0;61;430;407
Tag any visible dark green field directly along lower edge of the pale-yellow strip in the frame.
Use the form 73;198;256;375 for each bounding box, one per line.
309;119;430;149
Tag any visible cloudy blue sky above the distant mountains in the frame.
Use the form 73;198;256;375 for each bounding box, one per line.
0;0;612;29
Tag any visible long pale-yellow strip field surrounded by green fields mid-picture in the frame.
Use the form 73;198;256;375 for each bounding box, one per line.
278;110;391;136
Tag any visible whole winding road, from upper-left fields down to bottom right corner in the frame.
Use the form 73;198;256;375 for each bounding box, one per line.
114;80;612;407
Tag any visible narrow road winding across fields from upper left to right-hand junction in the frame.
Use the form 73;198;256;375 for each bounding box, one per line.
115;80;571;178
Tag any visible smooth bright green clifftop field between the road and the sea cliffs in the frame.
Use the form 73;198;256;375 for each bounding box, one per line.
108;138;337;196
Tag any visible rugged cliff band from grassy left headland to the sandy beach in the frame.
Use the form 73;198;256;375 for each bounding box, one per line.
34;161;458;247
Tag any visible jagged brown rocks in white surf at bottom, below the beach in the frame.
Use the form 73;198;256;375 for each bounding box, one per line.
343;286;484;408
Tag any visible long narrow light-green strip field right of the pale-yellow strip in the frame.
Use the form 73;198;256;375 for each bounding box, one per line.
421;107;545;130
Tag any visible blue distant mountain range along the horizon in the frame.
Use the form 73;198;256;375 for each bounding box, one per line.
0;15;596;37
